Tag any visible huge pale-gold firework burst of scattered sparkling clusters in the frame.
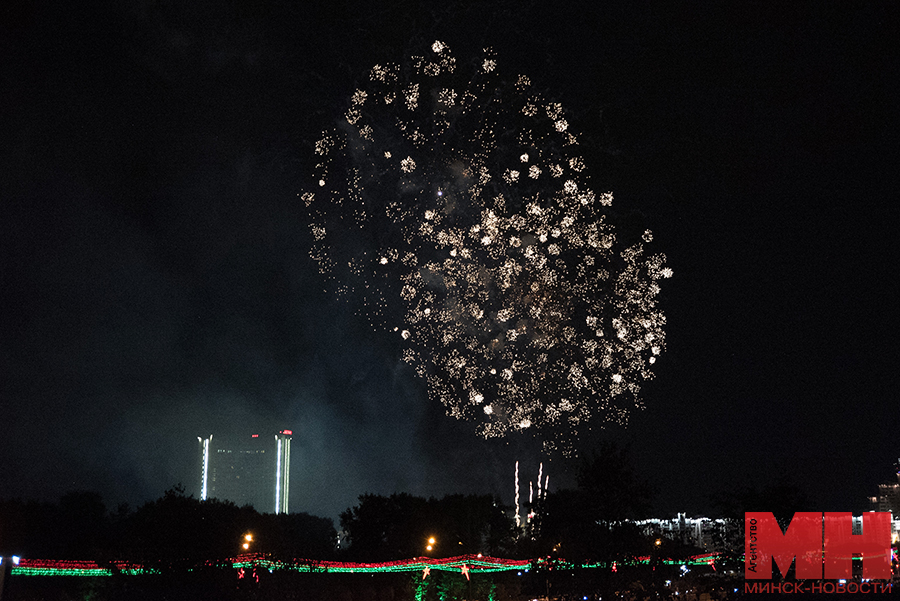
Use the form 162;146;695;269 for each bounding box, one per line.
302;42;671;450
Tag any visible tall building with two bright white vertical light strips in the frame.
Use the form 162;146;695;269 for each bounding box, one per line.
197;430;292;513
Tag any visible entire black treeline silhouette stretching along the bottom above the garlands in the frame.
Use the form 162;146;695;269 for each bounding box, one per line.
0;445;814;566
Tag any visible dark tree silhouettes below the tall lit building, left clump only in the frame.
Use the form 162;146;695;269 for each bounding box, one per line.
0;486;337;564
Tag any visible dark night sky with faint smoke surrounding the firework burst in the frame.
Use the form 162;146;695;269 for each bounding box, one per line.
0;0;900;517
